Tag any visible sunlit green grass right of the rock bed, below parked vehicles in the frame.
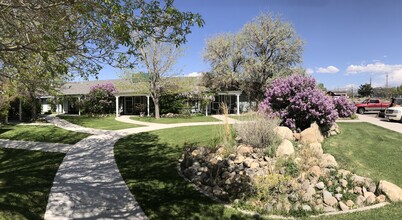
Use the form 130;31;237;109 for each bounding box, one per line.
323;123;402;187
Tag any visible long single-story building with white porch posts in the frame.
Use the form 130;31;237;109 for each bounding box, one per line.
36;77;255;116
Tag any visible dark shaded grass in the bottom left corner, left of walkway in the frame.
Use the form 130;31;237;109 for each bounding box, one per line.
0;148;64;219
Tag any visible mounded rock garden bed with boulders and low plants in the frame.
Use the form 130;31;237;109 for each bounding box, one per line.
180;124;402;216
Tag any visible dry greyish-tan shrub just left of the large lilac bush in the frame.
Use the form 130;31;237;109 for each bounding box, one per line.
234;111;279;153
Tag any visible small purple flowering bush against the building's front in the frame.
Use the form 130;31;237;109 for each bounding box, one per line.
83;83;117;115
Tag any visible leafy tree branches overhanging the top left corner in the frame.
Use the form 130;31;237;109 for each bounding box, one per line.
0;0;203;118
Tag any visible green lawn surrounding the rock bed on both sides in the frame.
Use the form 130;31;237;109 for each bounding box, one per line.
115;123;402;219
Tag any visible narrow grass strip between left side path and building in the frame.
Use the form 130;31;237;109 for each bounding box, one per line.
0;125;89;144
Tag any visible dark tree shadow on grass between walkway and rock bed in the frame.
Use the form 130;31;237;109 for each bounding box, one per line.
115;133;256;219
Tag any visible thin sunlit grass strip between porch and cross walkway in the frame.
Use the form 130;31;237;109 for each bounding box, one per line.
130;115;220;124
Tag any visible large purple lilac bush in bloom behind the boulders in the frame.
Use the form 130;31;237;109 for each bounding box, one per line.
259;75;338;131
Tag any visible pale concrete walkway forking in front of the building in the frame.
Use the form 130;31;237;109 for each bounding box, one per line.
41;116;234;219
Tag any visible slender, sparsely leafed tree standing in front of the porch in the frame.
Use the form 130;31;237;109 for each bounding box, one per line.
138;39;181;118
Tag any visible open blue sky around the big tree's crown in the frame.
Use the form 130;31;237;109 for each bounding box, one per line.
94;0;402;90
